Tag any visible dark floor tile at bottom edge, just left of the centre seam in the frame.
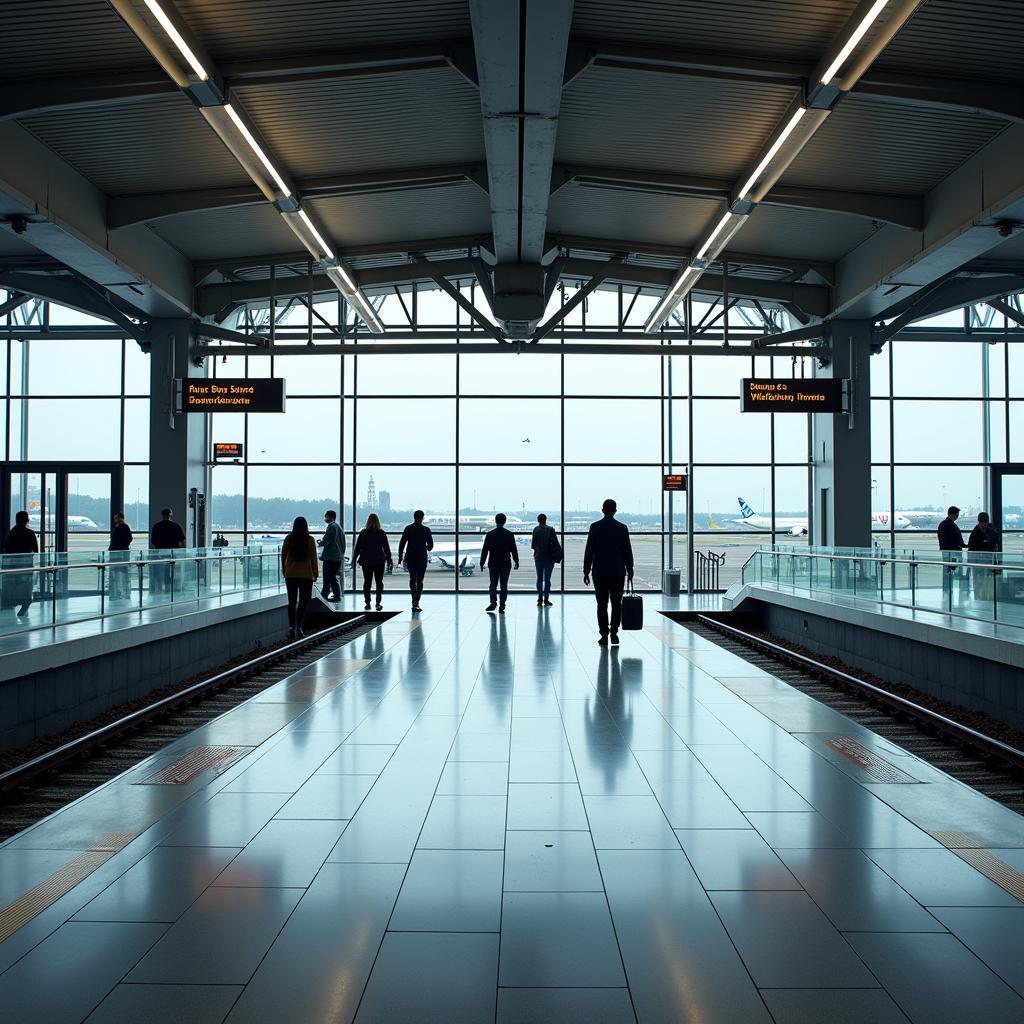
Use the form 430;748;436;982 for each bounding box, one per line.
356;932;498;1024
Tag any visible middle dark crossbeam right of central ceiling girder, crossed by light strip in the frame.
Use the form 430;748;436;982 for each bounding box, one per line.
552;164;924;230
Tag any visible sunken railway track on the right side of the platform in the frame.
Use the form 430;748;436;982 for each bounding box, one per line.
683;615;1024;814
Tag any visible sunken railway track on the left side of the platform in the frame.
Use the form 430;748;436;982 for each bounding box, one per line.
0;615;380;842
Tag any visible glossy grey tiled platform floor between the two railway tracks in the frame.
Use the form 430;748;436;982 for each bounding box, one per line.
0;595;1024;1024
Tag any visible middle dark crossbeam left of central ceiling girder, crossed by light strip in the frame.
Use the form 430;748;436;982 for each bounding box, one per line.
106;165;486;228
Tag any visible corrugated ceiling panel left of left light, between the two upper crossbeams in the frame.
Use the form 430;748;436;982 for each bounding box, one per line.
22;94;249;196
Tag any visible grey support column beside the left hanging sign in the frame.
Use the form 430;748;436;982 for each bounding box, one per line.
146;318;210;547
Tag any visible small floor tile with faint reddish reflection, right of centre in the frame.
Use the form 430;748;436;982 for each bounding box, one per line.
676;828;801;889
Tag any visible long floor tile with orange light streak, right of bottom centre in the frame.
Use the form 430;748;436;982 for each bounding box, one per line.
598;850;770;1024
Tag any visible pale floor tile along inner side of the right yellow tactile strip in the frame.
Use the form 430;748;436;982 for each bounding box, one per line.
867;850;1021;906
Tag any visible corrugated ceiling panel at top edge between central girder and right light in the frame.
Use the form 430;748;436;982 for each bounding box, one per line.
572;0;857;61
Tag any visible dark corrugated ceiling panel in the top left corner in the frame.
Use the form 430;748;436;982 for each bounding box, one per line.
0;0;154;79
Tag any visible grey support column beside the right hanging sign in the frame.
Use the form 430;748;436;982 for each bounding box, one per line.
810;321;871;548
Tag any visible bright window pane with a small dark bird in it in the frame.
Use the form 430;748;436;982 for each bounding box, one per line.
459;398;561;463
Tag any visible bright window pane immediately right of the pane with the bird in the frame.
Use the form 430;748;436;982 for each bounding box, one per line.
565;398;662;463
